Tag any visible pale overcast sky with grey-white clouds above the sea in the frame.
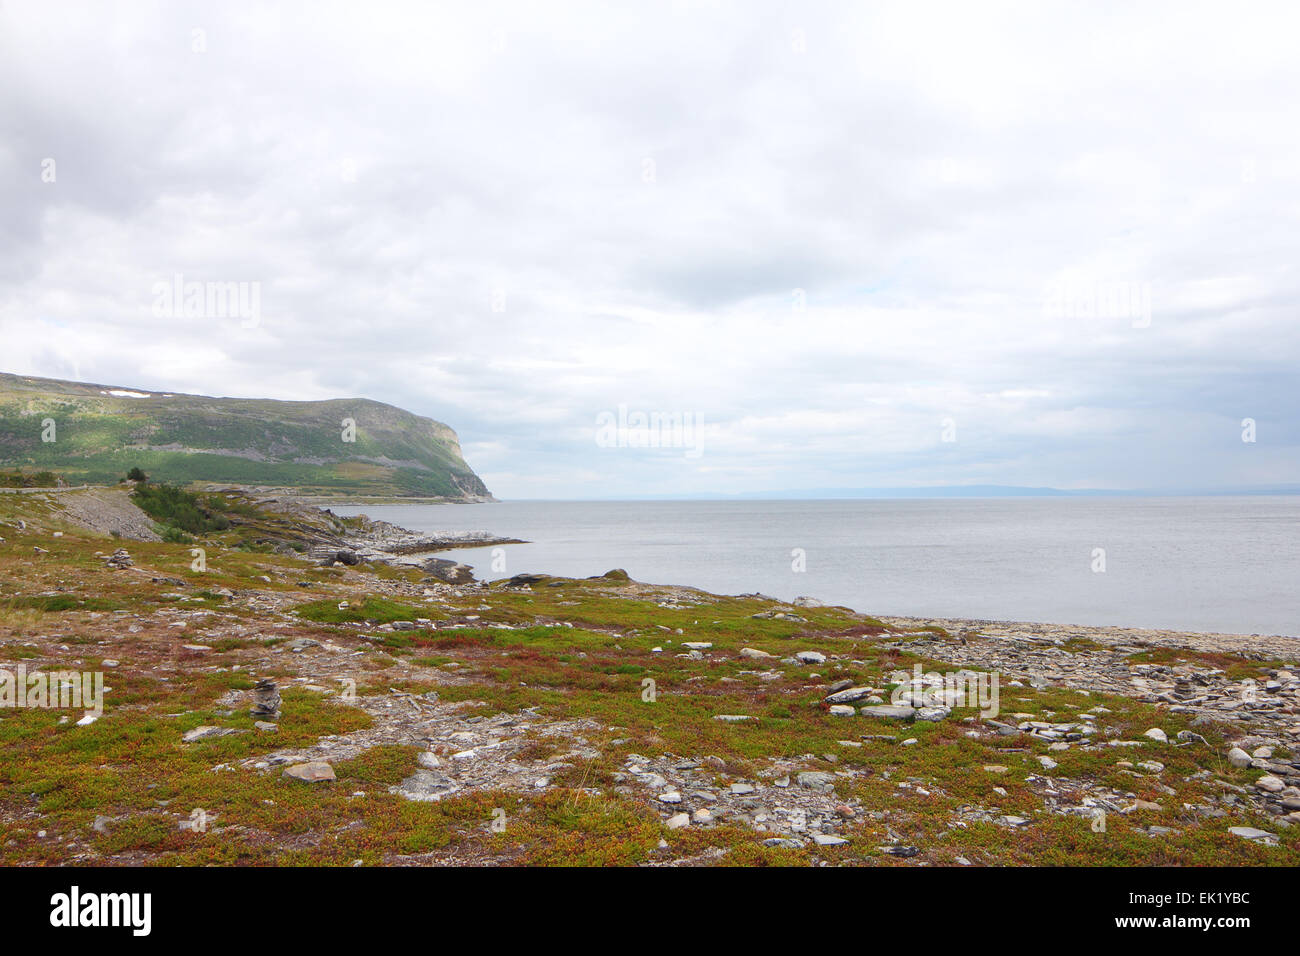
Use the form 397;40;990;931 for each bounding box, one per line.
0;0;1300;497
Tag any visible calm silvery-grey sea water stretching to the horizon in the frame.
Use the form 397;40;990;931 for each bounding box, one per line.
334;497;1300;635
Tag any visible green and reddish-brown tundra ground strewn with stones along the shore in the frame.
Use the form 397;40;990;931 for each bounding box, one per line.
0;486;1300;866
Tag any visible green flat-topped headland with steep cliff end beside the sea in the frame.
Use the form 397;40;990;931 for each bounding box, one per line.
0;372;491;499
